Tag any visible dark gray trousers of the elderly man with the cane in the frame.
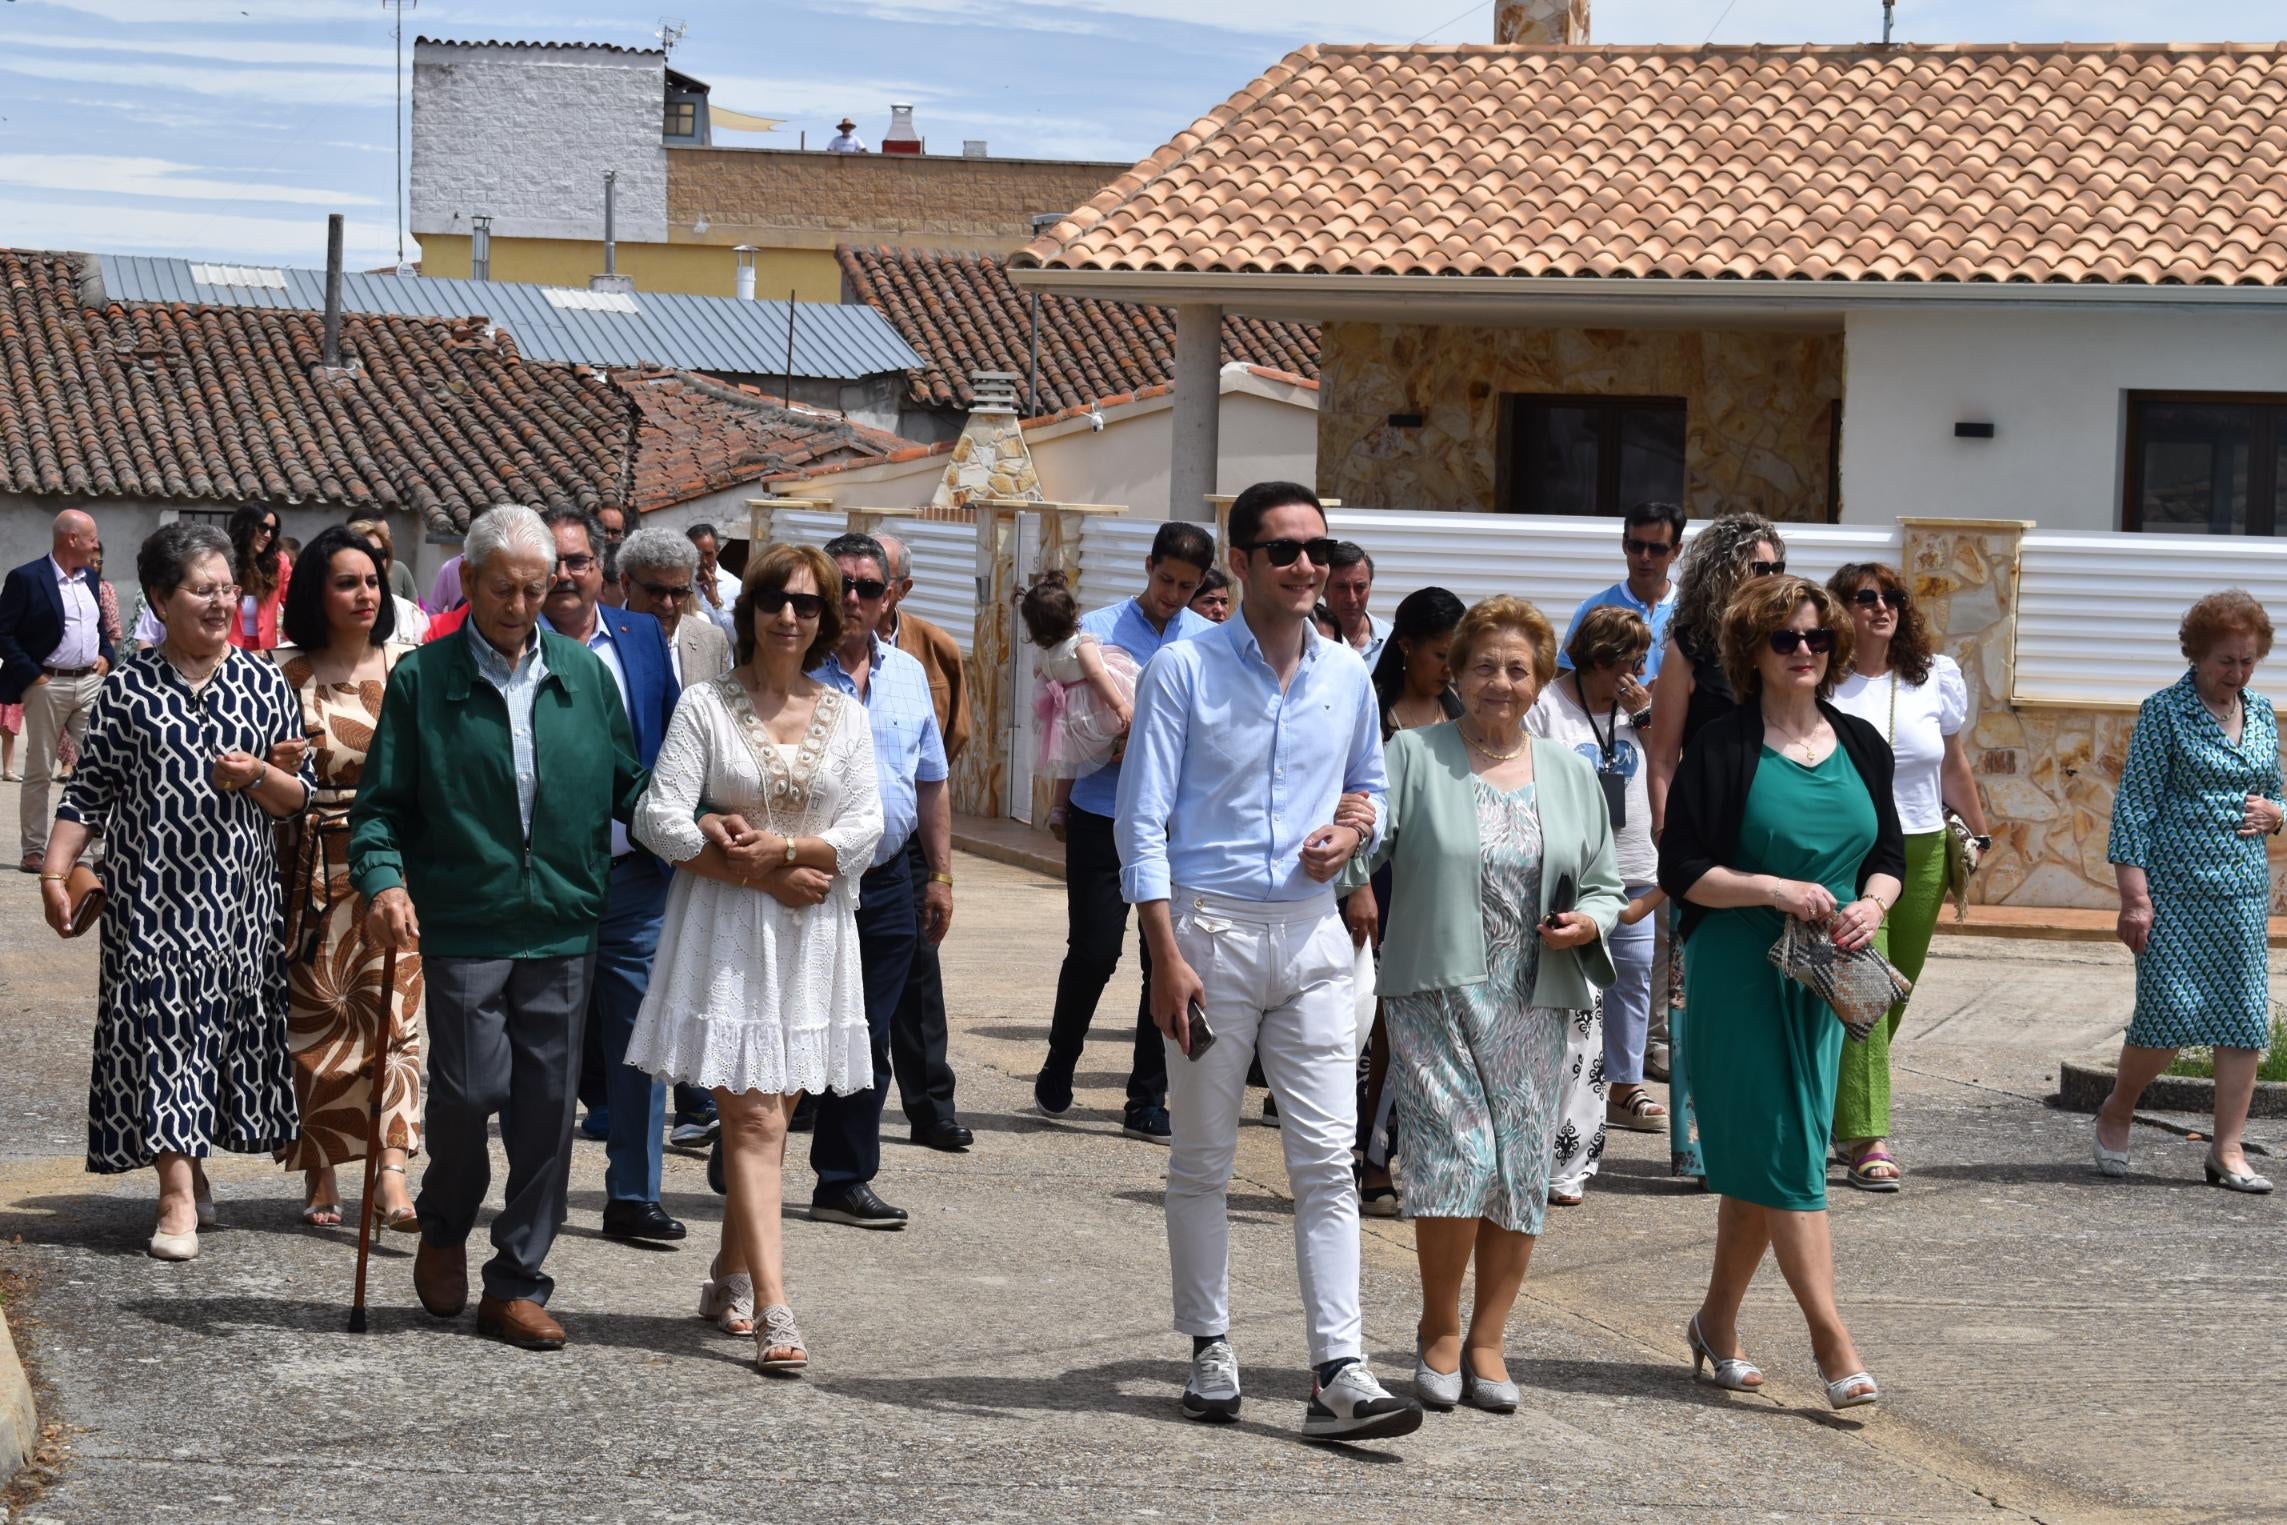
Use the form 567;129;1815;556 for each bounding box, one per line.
414;953;595;1303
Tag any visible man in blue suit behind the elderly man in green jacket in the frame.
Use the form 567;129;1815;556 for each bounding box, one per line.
540;508;684;1241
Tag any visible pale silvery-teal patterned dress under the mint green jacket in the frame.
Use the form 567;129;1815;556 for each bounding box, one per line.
1384;777;1576;1235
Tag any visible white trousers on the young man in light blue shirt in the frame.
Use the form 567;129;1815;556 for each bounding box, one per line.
1166;887;1365;1365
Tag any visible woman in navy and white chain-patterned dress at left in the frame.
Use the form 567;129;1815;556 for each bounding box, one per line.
39;524;311;1260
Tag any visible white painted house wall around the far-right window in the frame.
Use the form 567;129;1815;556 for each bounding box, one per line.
1843;309;2287;530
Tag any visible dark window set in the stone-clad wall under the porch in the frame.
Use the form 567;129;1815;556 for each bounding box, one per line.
1500;396;1683;514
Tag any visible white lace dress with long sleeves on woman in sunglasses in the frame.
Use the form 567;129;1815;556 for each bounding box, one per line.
627;672;880;1095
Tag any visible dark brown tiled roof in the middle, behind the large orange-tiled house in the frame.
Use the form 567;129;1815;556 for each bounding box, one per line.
835;245;1317;414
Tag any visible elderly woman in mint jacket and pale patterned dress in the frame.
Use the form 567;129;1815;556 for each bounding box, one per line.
1342;599;1628;1413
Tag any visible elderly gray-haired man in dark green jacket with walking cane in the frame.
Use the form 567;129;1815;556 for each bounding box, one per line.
350;508;647;1349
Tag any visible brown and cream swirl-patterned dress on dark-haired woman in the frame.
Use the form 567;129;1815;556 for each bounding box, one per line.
272;642;421;1171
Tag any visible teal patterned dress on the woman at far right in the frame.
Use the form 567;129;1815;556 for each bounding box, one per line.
2106;672;2280;1049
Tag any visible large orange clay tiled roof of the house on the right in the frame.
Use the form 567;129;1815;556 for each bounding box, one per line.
1015;43;2287;286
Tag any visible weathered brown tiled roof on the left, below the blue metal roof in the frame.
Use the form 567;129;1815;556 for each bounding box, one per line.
0;249;908;530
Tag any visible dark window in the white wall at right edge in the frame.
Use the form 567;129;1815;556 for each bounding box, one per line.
2120;393;2287;535
